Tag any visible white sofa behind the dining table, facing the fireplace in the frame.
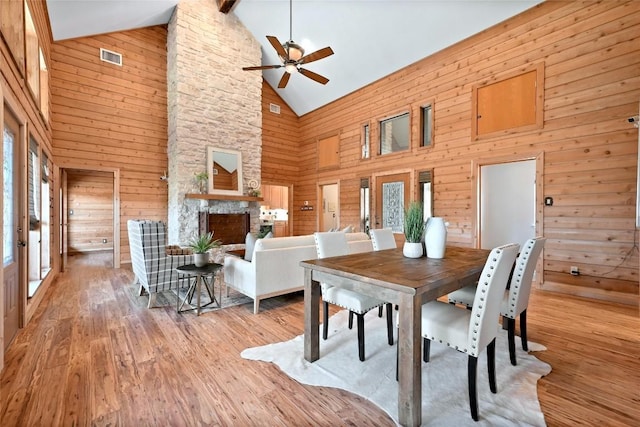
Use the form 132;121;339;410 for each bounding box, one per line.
224;233;373;314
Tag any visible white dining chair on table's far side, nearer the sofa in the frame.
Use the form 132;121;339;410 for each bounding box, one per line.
314;232;393;361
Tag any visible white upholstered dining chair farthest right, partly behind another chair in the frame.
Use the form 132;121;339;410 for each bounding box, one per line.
448;237;547;366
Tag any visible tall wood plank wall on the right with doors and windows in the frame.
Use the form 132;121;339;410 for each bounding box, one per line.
263;1;640;304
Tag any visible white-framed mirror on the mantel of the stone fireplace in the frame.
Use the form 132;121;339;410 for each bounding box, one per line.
207;147;243;196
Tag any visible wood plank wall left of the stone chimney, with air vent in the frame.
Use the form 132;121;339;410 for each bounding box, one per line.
51;26;168;261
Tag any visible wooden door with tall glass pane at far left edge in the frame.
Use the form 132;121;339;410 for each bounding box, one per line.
2;108;25;350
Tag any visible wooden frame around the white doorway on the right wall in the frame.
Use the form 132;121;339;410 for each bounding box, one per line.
471;151;544;288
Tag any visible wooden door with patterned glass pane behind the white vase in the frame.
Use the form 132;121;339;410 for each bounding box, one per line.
375;172;411;233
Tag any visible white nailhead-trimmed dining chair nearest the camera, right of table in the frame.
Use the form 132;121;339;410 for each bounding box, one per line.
422;243;519;421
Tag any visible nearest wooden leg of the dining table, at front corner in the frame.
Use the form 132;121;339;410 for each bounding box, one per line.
398;294;422;426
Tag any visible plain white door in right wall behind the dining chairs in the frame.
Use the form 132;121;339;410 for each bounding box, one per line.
480;160;536;249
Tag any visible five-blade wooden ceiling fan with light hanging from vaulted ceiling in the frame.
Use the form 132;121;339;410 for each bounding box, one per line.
242;0;333;89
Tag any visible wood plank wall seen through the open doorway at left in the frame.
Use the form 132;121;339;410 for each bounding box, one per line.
67;169;113;253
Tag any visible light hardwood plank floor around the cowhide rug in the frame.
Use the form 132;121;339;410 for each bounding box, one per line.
0;259;640;426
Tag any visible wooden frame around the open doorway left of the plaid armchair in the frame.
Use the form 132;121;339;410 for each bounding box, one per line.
58;161;121;270
